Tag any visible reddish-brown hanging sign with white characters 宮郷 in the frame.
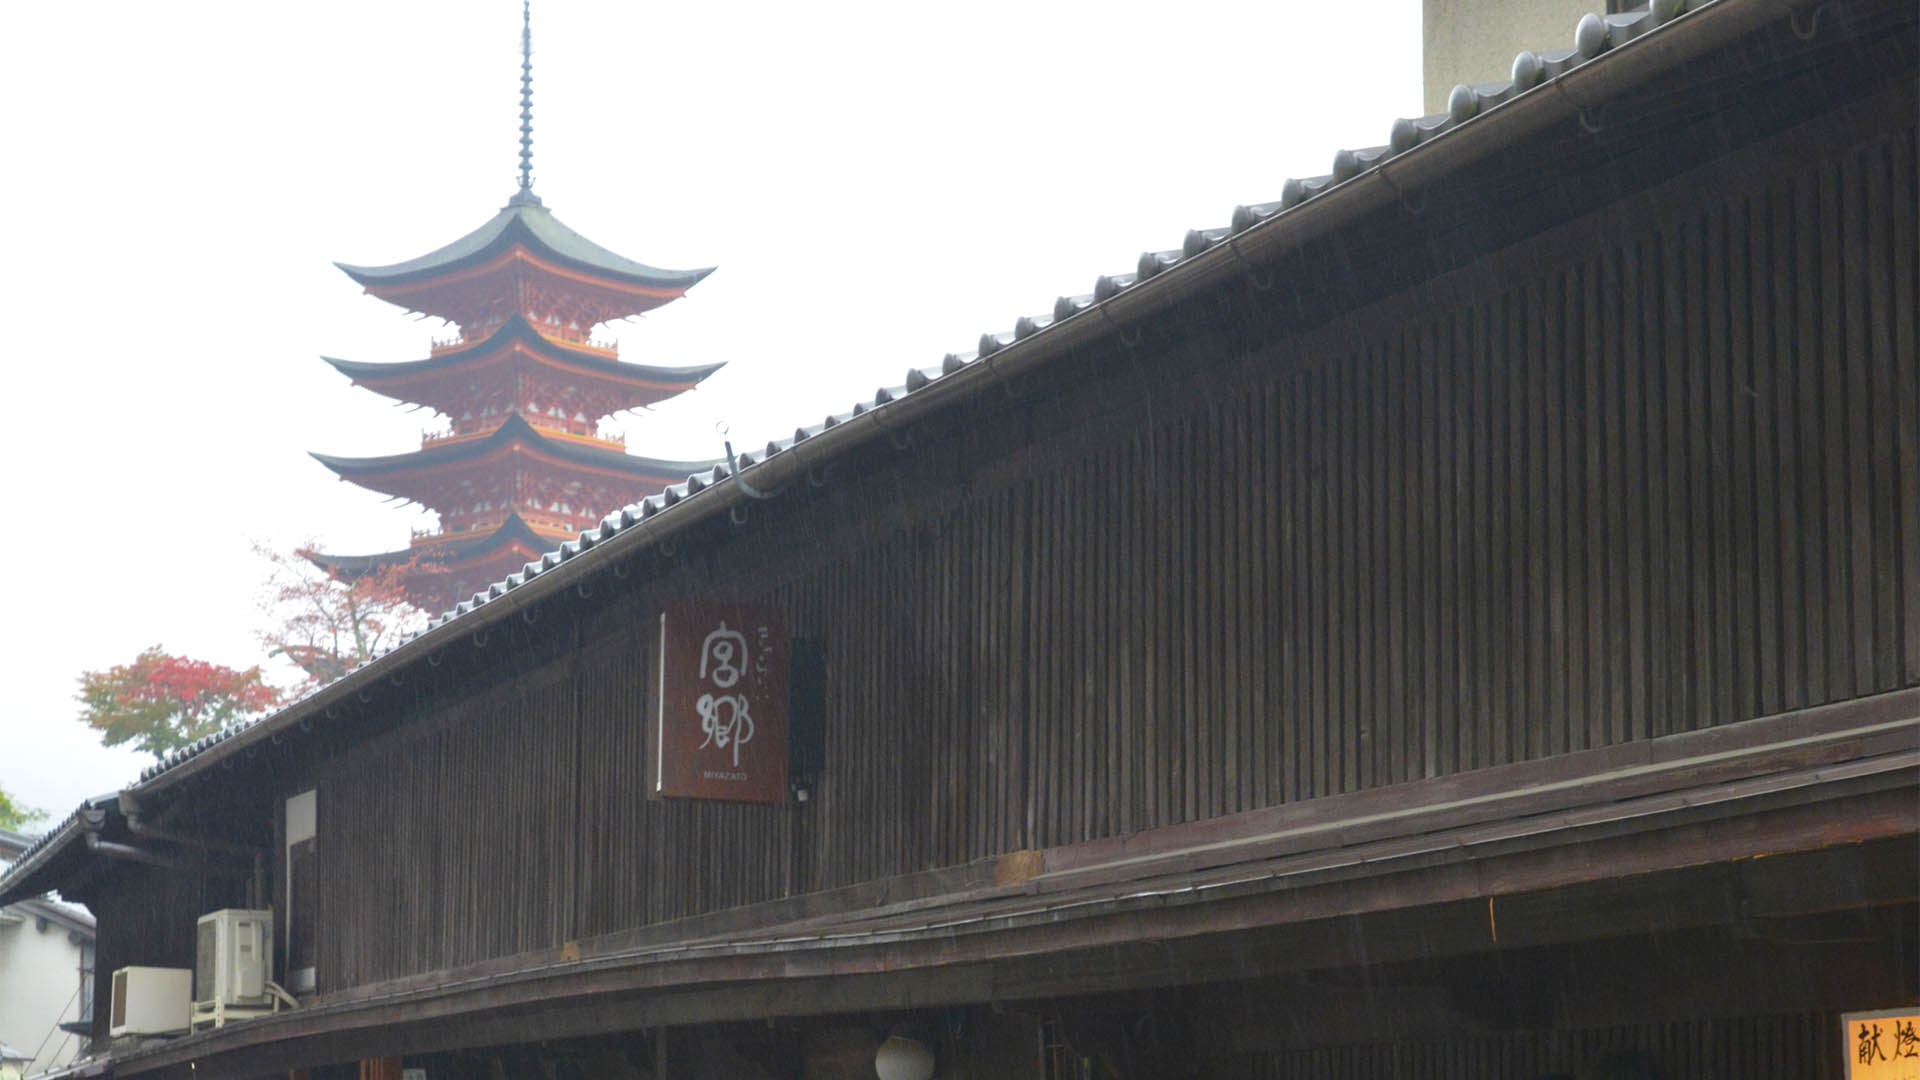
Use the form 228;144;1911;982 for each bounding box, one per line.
647;600;791;803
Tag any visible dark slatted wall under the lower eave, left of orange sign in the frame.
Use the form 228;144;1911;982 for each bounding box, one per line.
1244;1015;1847;1080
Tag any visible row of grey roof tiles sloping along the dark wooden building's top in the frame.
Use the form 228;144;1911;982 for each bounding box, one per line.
0;0;1743;857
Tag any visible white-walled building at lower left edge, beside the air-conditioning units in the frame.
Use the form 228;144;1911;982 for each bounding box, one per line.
0;907;83;1076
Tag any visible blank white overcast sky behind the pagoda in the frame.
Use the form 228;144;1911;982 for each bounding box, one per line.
0;0;1421;819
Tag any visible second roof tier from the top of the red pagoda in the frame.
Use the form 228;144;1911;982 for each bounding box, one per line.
321;315;726;421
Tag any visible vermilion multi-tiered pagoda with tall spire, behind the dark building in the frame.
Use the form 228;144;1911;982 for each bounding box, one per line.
313;0;720;609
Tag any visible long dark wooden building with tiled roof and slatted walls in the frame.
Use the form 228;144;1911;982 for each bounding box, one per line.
0;0;1920;1080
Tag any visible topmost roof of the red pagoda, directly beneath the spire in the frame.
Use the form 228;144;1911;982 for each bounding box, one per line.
334;198;712;321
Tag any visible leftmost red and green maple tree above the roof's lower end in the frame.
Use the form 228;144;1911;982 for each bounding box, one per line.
79;646;280;757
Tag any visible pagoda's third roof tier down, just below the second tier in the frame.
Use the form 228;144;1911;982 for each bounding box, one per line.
313;413;714;509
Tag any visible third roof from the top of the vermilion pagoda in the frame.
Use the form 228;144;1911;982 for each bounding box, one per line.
313;413;714;502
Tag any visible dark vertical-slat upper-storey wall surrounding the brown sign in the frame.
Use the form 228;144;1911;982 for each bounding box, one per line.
307;122;1920;988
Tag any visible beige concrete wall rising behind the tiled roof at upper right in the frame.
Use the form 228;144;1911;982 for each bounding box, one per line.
1421;0;1607;115
